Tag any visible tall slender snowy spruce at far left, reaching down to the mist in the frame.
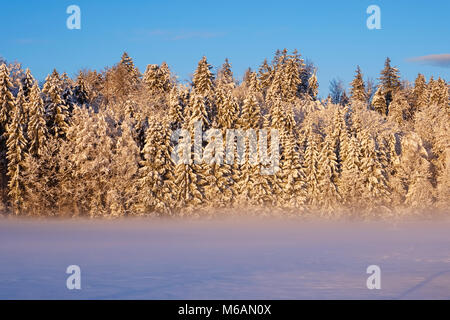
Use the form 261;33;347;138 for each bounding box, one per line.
6;99;27;214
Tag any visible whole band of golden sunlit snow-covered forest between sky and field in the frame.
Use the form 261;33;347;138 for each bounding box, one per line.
0;50;450;218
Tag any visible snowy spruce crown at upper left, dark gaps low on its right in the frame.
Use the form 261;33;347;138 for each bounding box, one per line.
42;70;69;138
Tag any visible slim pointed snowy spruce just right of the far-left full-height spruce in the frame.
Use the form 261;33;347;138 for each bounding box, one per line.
27;83;48;157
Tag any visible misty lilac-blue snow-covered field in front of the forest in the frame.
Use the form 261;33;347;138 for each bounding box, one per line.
0;218;450;299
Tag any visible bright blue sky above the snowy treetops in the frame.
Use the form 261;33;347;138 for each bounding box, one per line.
0;0;450;96
